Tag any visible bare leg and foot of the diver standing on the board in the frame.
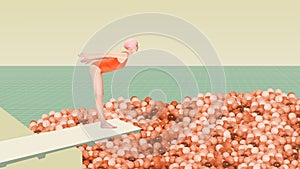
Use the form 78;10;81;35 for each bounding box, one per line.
90;64;116;128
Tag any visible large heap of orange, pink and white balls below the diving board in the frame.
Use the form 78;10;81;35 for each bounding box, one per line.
29;89;300;169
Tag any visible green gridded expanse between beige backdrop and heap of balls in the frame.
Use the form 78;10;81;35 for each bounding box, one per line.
0;66;300;126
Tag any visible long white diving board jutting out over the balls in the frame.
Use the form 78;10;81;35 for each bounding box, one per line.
0;119;141;168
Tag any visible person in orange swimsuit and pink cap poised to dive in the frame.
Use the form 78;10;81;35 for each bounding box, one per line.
78;38;138;128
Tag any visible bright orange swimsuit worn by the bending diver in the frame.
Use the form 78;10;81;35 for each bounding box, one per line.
93;51;127;73
